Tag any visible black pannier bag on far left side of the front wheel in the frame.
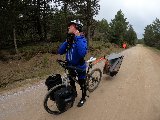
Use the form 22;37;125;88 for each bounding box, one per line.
45;74;62;101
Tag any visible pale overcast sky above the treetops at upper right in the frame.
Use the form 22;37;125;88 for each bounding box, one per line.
96;0;160;38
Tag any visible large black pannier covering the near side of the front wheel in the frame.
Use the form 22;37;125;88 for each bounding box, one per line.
54;86;76;112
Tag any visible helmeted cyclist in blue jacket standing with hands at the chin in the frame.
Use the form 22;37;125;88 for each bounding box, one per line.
58;20;87;107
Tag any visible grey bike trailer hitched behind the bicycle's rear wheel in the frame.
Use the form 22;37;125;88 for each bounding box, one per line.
103;53;124;77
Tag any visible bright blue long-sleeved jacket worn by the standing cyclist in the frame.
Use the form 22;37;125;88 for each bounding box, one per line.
58;36;87;69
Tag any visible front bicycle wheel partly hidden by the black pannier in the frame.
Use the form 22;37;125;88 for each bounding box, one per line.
43;84;65;115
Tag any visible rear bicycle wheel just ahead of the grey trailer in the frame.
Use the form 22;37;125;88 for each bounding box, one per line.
87;68;102;92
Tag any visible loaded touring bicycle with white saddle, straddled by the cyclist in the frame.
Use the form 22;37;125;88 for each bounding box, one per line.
44;58;102;115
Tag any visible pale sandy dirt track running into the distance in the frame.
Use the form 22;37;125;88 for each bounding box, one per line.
0;45;160;120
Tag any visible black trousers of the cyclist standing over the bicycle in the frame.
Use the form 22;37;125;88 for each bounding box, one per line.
69;70;86;99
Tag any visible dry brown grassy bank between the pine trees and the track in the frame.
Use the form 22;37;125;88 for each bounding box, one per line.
0;41;123;92
